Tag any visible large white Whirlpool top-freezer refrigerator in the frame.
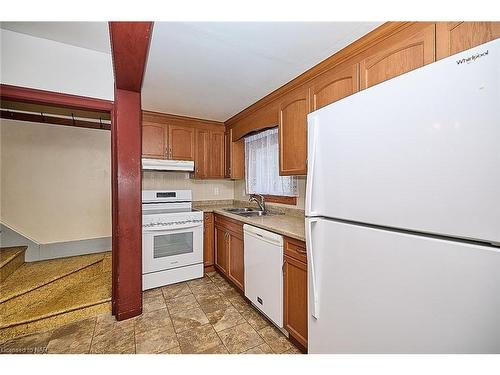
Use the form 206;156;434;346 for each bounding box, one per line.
306;40;500;353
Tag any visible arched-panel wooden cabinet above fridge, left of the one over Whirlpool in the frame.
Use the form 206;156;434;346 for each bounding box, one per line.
359;23;435;89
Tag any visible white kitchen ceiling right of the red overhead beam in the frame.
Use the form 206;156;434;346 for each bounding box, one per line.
142;22;381;121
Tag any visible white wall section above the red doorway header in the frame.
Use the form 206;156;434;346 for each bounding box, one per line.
0;29;114;100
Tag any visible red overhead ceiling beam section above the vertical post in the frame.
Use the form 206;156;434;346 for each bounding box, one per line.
109;22;153;92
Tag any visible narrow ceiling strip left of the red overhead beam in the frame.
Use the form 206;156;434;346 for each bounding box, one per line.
1;22;111;54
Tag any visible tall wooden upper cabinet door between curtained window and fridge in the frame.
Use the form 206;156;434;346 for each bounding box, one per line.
278;88;308;176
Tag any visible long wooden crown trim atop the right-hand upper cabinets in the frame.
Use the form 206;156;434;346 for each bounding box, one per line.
225;22;415;128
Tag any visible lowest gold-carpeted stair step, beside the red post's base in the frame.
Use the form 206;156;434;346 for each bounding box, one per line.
0;272;111;340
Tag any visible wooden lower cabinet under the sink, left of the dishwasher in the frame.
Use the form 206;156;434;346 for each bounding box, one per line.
214;214;245;291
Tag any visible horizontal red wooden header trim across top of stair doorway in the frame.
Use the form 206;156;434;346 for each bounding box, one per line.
0;84;113;113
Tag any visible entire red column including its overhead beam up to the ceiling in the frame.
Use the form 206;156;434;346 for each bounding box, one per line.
109;22;153;320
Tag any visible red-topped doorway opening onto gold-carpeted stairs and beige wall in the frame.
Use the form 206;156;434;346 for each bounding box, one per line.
0;85;114;340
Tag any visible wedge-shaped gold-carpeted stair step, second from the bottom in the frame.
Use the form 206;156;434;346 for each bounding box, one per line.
0;253;106;304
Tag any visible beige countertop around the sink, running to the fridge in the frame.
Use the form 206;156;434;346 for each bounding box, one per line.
193;202;306;241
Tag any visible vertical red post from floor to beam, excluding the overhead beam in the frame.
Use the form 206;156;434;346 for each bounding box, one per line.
112;89;142;320
